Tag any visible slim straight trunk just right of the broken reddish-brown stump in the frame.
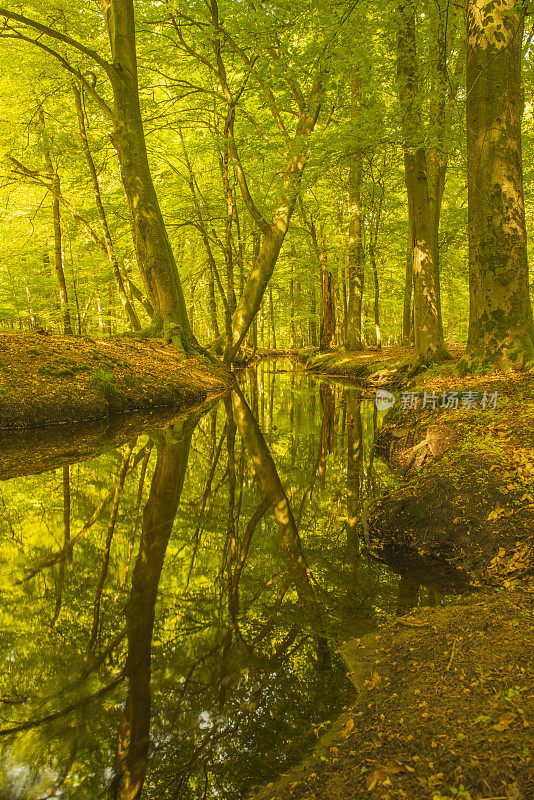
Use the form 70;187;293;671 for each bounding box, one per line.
345;78;365;350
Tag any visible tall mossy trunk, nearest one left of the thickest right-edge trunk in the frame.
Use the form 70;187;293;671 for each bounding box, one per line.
397;0;447;363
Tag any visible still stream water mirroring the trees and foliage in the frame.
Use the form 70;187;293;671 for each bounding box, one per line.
0;362;418;800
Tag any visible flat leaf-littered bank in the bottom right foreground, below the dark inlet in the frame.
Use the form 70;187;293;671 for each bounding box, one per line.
253;581;534;800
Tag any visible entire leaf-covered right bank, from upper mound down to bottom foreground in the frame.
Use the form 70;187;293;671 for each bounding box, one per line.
254;360;534;800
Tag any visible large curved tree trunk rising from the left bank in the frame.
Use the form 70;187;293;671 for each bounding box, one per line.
102;0;205;355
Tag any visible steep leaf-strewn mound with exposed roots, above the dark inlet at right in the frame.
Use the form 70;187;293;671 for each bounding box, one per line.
369;372;534;584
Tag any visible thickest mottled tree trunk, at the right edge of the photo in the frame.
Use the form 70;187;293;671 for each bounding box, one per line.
461;0;534;371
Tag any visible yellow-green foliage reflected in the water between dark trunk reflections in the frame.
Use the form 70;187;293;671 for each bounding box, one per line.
0;367;402;800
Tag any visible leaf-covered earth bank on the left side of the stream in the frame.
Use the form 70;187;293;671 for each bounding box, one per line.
0;334;233;430
